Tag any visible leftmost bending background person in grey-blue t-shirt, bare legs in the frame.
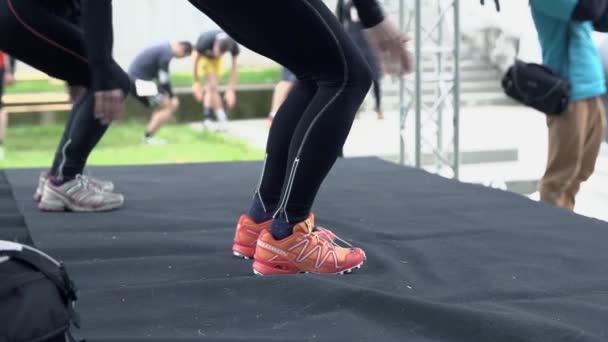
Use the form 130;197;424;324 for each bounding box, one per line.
128;41;192;145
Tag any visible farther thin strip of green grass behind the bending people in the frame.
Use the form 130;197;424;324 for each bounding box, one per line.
6;68;281;94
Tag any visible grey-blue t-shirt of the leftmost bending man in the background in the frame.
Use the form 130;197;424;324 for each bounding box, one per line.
129;42;173;95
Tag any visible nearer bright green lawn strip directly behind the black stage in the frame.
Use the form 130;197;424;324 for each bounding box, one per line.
0;122;263;168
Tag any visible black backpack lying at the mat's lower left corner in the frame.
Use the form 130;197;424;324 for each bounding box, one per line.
0;240;79;342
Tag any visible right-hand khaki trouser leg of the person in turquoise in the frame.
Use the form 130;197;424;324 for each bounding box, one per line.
564;97;606;208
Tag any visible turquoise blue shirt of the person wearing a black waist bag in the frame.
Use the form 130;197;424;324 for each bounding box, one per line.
530;0;606;101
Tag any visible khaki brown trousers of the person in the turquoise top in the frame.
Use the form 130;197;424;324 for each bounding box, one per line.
540;97;606;210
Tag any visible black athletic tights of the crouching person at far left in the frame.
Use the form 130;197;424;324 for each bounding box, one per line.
0;0;130;180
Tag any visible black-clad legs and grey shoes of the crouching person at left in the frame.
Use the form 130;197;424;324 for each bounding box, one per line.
0;0;130;211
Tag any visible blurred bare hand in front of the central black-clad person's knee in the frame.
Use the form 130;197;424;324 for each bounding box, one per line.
366;19;414;75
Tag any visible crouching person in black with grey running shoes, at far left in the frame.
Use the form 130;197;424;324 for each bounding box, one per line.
0;0;126;212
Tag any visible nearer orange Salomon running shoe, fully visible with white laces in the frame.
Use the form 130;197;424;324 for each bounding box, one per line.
253;220;365;275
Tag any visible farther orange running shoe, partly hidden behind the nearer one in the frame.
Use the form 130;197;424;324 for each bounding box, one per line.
232;213;336;259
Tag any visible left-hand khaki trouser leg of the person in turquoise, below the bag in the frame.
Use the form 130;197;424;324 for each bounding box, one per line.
540;101;589;209
